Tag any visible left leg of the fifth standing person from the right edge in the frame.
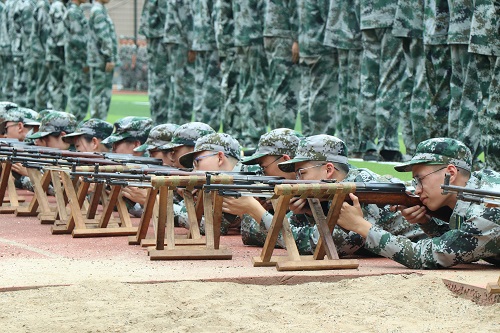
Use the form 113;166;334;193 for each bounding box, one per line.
358;29;381;154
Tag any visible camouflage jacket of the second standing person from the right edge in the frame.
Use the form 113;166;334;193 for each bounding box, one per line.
448;0;474;44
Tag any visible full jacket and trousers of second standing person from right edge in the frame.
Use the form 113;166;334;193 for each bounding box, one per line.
448;0;474;138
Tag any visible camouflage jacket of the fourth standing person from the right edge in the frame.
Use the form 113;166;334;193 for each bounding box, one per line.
392;0;424;39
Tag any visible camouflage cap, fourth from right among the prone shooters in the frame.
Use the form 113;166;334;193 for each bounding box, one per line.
179;133;241;168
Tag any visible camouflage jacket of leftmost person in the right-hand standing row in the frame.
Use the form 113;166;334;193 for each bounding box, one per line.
139;0;167;38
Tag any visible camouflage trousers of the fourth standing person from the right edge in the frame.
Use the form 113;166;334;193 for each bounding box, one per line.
399;38;424;155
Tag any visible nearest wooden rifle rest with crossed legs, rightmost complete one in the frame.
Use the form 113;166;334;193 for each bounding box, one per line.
252;183;359;271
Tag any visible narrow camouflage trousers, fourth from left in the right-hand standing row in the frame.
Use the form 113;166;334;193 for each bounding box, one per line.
220;48;243;142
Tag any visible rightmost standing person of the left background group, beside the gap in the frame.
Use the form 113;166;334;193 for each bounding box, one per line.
88;0;119;120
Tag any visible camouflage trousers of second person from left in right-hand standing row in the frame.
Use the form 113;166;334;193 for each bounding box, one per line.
166;44;195;125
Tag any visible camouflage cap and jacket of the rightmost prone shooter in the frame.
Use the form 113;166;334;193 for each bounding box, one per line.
365;138;500;269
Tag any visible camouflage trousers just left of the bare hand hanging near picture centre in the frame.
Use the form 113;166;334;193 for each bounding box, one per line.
264;37;300;129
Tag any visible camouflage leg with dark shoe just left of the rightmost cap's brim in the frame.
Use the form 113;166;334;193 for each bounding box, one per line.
376;29;405;161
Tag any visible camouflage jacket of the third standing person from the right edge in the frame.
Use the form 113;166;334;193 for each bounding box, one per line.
424;0;450;45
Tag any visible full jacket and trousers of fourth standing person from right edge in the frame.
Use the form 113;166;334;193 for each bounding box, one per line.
392;0;426;155
